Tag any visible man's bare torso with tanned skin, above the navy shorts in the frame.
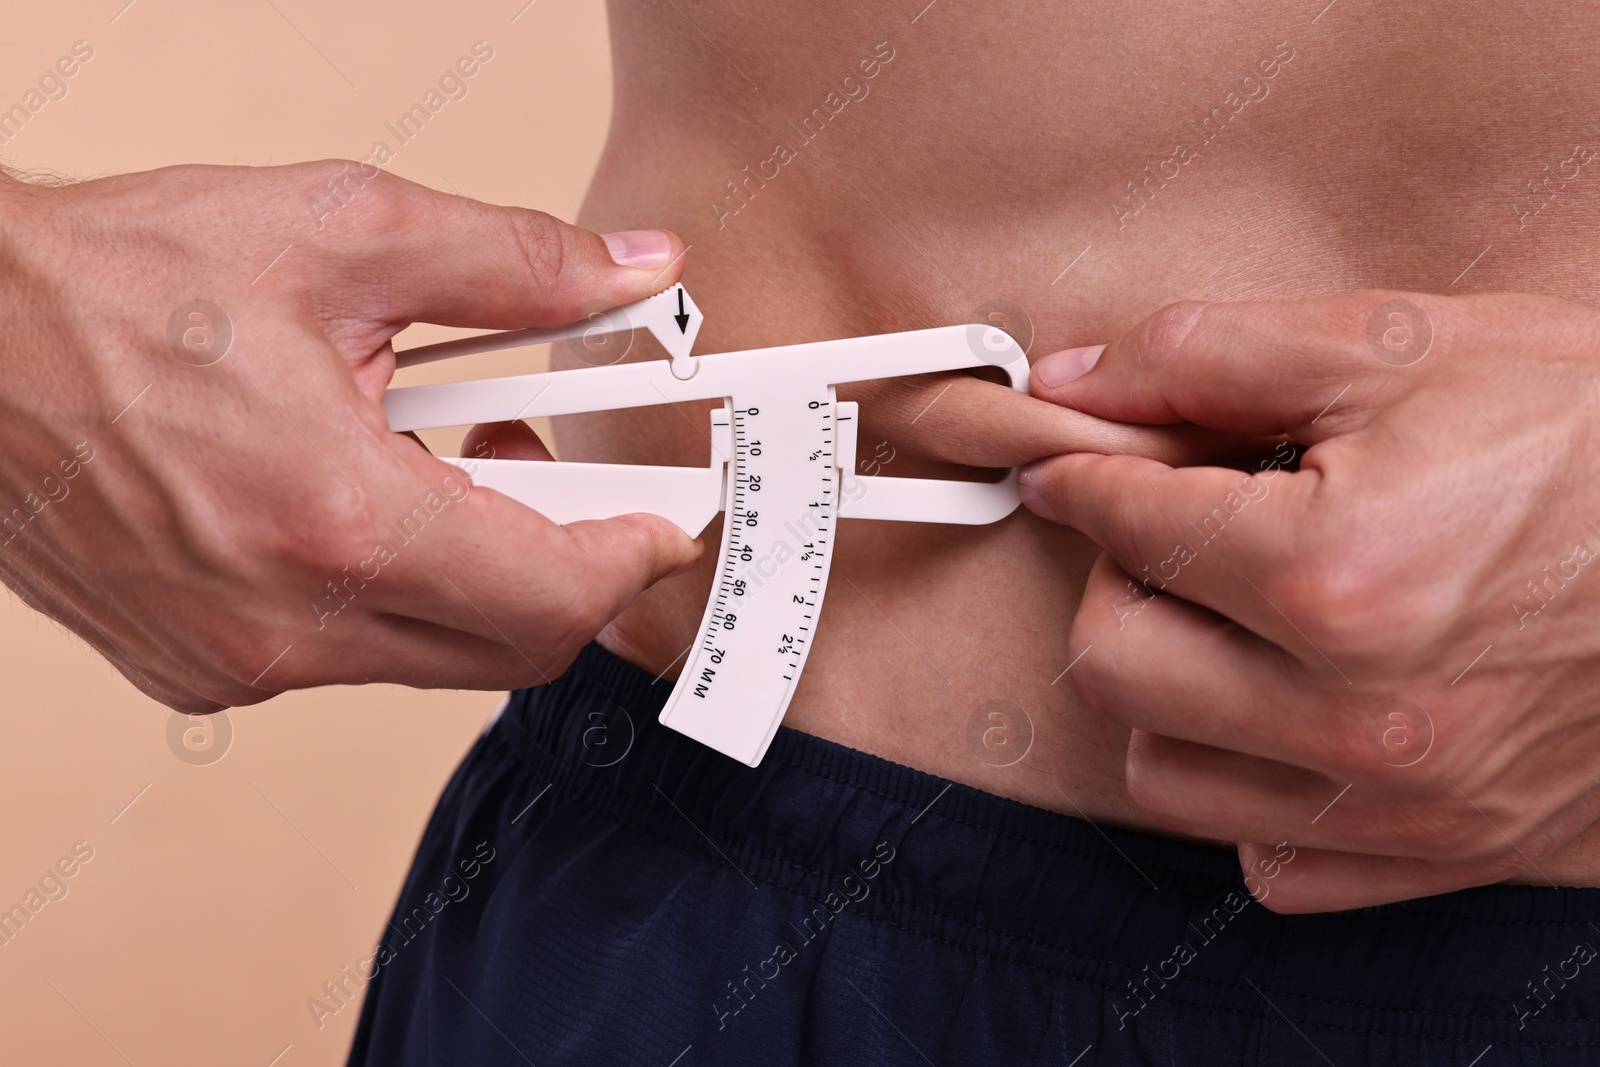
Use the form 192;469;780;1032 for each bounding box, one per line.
557;0;1600;885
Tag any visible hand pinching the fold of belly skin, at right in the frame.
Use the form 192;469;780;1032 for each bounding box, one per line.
1022;293;1600;912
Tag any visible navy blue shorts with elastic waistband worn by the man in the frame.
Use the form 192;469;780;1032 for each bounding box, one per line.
350;648;1600;1067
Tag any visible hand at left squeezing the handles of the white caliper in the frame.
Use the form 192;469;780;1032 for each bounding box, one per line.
0;163;701;712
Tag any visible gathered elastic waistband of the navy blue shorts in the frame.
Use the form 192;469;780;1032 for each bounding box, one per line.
494;646;1600;1032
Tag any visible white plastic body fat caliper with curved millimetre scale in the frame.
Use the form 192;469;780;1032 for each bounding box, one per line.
393;286;1027;766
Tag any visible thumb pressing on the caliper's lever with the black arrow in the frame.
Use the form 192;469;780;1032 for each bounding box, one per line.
331;174;685;330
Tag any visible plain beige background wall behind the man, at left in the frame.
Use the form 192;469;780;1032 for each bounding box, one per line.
0;0;610;1067
